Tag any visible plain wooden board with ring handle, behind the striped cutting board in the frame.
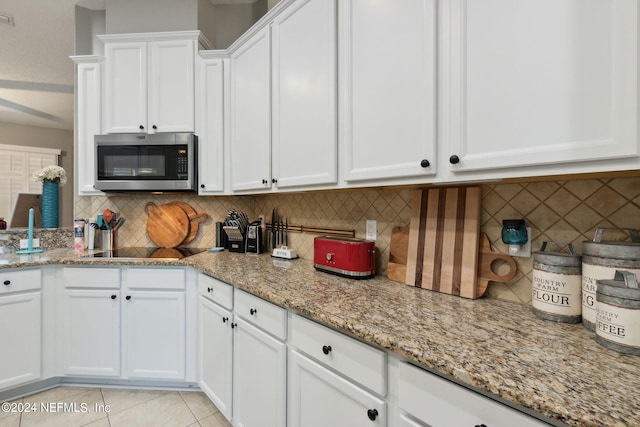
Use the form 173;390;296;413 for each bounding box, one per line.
387;227;518;298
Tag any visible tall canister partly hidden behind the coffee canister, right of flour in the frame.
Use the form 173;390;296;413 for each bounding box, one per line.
582;228;640;331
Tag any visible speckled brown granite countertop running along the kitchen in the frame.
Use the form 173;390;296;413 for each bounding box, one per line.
0;249;640;426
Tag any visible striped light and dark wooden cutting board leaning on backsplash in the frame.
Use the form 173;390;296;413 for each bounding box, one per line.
405;187;482;298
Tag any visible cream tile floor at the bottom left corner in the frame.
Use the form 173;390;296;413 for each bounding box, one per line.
0;386;230;427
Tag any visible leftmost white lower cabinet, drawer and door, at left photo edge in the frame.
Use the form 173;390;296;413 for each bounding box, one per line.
0;269;42;390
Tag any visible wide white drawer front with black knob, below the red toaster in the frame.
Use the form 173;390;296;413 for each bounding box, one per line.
290;315;387;396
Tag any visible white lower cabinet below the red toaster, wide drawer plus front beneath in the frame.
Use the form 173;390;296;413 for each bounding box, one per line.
287;314;387;427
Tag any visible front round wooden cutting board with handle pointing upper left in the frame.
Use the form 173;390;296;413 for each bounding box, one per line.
144;202;190;248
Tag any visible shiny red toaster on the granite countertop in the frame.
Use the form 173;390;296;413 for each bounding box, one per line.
313;236;376;279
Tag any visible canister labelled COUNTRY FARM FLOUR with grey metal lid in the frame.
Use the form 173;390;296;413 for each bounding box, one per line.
531;242;582;323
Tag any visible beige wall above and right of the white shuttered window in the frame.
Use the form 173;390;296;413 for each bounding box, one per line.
0;122;73;227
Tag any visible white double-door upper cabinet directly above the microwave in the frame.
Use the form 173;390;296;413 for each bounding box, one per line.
100;32;199;133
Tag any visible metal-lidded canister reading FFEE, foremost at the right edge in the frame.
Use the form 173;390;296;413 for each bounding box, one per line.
596;270;640;355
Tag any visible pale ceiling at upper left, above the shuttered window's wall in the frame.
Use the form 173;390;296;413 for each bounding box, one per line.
0;0;262;130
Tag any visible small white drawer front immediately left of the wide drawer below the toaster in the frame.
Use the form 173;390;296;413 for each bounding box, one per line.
234;289;287;340
